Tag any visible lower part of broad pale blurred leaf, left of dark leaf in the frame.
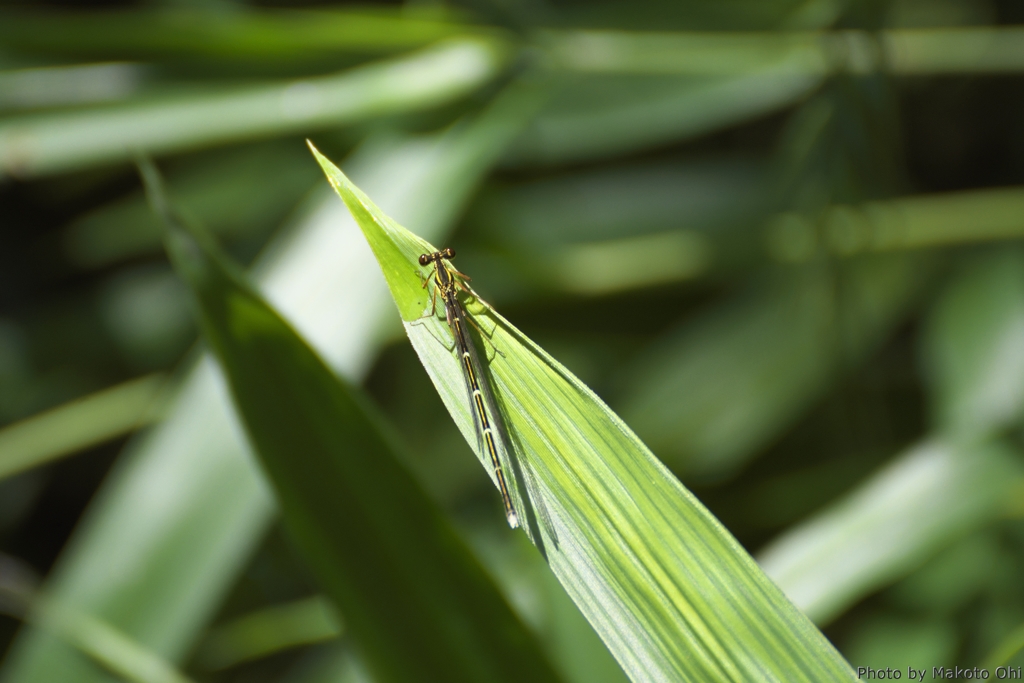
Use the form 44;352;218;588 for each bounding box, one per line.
3;359;271;683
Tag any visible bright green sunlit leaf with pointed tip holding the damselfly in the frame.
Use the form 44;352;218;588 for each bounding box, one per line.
314;145;853;681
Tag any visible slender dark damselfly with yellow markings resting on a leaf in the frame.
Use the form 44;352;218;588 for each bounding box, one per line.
420;247;519;528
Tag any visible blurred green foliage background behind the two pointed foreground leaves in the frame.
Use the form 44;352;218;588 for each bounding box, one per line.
0;0;1024;683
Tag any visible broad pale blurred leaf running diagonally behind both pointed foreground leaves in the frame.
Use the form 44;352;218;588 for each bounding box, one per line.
3;93;544;683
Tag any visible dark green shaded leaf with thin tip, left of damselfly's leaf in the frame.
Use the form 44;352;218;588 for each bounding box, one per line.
153;157;558;682
